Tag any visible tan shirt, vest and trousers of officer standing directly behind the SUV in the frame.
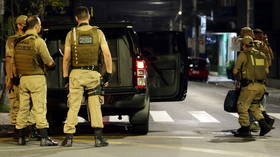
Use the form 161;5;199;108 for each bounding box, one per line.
62;23;108;146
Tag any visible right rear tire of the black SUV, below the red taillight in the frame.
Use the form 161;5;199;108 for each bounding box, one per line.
129;96;150;135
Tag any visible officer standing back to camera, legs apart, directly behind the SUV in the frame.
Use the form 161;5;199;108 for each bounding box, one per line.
61;7;112;147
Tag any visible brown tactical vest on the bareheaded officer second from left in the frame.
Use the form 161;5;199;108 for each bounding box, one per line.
14;35;44;76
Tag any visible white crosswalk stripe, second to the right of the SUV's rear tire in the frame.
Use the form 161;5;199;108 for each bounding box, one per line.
189;111;220;123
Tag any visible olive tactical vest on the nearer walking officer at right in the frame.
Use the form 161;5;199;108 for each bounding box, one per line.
242;50;267;81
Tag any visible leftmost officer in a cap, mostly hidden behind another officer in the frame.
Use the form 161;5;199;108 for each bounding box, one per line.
5;15;38;138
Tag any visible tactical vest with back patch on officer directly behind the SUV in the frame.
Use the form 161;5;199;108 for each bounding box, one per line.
71;27;100;67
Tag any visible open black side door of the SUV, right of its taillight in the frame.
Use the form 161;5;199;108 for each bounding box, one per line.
138;31;188;101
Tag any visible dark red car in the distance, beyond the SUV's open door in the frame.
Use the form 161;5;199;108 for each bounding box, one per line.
187;57;209;81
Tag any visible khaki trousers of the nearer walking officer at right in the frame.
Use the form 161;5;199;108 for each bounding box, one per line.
237;83;265;127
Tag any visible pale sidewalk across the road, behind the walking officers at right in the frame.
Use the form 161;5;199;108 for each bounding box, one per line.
207;75;280;105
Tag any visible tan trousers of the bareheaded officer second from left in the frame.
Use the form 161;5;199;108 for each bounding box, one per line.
16;75;49;129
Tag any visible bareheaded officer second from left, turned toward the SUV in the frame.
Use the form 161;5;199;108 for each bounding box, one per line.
14;16;58;146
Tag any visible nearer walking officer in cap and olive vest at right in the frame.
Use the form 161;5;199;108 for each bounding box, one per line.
233;36;271;137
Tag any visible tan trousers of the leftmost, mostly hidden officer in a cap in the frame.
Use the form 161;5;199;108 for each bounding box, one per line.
8;85;35;125
